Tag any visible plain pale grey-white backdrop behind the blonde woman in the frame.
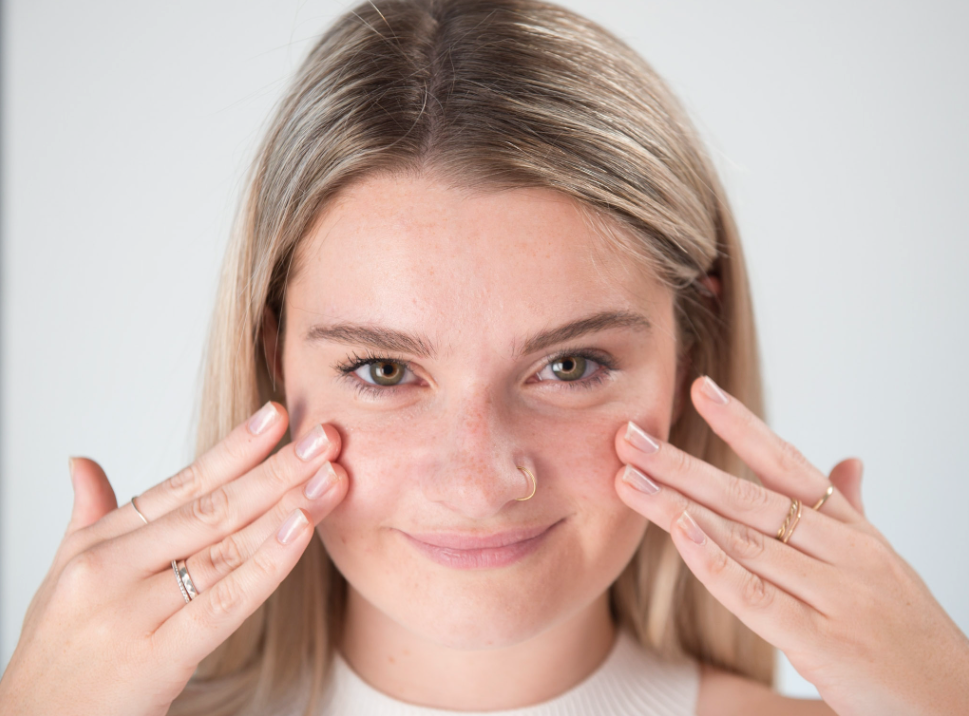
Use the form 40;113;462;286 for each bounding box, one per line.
0;0;969;695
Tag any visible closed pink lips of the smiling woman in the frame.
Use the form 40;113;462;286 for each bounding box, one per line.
401;520;561;569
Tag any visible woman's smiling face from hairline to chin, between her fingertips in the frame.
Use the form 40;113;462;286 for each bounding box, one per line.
281;175;677;649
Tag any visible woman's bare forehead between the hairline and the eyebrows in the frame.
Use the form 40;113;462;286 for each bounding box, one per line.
287;175;664;350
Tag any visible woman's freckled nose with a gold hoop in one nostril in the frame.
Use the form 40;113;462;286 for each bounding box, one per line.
421;387;534;520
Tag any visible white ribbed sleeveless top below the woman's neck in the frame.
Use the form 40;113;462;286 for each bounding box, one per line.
321;631;700;716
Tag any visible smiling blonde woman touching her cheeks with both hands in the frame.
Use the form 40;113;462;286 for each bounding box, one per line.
0;0;969;715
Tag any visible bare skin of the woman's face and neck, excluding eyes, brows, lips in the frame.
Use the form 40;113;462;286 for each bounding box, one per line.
267;176;676;709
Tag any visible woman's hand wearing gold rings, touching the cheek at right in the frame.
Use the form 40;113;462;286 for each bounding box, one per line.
616;378;969;716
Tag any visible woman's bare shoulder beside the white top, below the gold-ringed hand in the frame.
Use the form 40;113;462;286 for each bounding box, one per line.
696;664;835;716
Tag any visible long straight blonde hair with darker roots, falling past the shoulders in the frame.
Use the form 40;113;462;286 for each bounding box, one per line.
170;0;774;714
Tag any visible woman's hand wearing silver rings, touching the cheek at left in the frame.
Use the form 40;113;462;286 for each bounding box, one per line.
0;403;347;716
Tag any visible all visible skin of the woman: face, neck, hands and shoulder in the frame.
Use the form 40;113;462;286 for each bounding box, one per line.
0;175;969;716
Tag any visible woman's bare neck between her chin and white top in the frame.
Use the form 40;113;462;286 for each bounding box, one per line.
340;586;616;711
